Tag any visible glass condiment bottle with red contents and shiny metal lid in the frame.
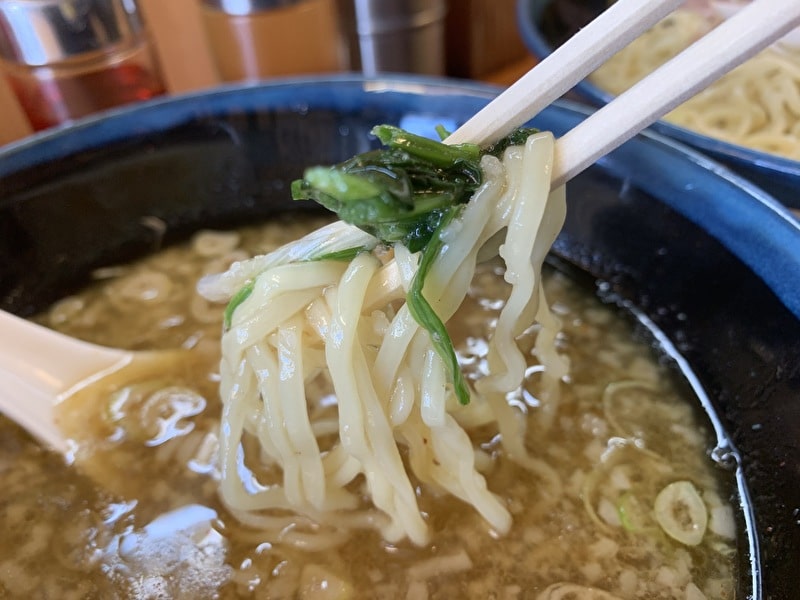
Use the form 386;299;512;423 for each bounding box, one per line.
0;0;164;130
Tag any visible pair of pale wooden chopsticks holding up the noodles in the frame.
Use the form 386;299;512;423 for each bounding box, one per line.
445;0;800;187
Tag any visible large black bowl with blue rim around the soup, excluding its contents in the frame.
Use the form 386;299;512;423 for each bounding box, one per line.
0;77;800;599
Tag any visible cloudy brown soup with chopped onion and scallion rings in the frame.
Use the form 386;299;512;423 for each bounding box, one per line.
0;220;736;600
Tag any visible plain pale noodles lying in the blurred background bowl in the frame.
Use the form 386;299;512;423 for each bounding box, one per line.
590;9;800;160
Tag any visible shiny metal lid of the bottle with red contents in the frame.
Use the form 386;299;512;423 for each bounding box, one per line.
0;0;143;66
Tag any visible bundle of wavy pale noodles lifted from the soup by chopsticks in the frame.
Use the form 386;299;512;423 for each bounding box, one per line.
199;133;567;549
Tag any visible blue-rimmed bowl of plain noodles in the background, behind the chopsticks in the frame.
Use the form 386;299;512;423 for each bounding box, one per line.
517;0;800;208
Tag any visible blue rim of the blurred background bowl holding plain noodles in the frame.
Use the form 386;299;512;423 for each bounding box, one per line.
516;0;800;178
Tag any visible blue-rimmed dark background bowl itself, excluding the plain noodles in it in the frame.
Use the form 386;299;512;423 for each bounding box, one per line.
517;0;800;208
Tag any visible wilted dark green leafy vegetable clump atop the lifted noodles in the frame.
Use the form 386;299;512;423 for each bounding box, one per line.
288;125;534;404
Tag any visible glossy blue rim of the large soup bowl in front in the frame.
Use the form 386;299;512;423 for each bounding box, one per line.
0;74;800;318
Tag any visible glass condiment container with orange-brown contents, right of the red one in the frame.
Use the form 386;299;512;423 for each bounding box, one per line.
200;0;347;81
